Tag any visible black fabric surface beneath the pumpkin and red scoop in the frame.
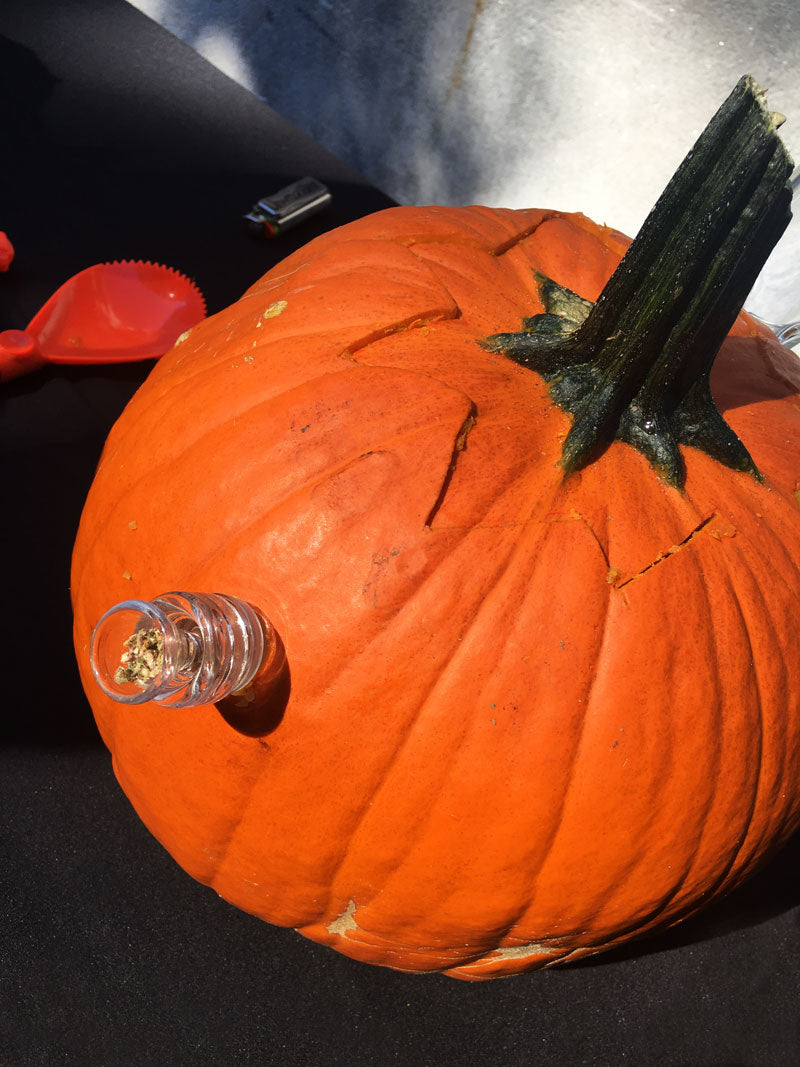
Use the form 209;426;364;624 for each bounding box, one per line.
0;0;800;1067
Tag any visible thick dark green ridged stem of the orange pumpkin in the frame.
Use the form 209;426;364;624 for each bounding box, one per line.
482;75;793;488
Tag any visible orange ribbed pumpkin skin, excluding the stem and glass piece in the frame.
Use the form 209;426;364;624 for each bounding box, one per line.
71;207;800;980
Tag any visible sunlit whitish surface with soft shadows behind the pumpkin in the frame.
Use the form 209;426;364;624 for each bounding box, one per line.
131;0;800;322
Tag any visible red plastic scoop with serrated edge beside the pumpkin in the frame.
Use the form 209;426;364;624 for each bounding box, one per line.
0;261;206;380
